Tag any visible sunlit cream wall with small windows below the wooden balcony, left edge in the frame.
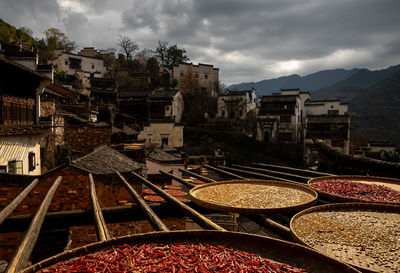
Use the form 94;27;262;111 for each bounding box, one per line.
0;134;43;175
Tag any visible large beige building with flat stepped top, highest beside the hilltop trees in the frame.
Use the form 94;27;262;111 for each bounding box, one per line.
163;63;219;97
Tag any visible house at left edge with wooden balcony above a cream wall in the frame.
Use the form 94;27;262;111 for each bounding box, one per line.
0;56;51;175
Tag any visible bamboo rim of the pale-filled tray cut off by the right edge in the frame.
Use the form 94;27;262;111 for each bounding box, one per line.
289;202;400;273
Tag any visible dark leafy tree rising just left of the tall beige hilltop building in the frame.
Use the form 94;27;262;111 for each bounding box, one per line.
155;40;190;67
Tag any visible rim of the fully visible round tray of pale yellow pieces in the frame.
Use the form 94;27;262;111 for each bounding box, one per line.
189;179;318;214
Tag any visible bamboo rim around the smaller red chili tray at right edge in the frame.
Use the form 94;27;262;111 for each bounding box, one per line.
307;175;400;205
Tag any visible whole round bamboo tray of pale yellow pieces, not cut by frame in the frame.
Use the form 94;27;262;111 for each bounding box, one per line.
189;180;318;214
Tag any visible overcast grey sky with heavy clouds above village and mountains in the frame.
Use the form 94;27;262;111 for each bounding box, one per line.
0;0;400;85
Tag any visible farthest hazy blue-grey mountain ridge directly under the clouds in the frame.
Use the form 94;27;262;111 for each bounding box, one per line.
227;69;358;96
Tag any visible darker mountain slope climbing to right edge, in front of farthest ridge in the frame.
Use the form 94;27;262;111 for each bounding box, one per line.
312;65;400;102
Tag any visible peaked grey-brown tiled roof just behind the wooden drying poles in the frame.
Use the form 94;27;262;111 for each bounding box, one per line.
71;146;143;175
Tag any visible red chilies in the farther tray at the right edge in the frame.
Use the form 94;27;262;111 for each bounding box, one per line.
310;179;400;203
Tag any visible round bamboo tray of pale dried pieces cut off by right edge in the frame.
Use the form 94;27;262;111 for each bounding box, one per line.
290;203;400;272
